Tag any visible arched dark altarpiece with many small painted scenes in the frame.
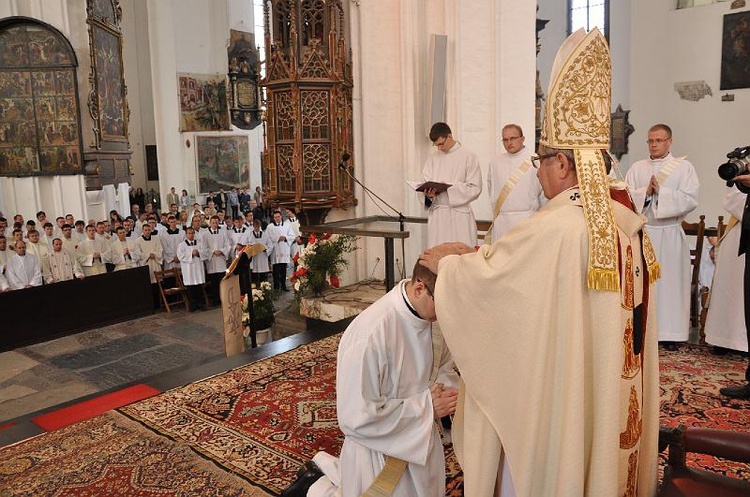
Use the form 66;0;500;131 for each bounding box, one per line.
0;17;82;176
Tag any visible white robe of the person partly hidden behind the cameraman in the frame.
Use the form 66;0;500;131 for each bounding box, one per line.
705;187;748;352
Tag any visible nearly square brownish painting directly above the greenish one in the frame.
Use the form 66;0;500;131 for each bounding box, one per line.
179;74;229;131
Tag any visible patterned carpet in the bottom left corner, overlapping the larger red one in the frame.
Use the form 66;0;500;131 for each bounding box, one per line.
0;411;269;497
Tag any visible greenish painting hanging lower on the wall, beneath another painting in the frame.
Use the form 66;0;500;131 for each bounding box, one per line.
195;135;250;193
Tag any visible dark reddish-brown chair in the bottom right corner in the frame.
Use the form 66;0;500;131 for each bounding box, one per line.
658;425;750;497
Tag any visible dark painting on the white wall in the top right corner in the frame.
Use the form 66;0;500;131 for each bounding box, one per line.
720;11;750;90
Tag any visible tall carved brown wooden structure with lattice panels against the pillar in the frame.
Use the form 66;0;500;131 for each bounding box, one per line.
261;0;357;219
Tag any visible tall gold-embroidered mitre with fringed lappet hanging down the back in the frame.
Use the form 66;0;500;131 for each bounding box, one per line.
539;28;620;291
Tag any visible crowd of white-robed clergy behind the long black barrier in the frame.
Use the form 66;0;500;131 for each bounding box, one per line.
0;200;301;310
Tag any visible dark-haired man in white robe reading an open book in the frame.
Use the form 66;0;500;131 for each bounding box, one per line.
422;123;482;247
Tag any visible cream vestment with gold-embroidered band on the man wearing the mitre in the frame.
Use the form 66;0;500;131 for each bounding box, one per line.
424;186;659;496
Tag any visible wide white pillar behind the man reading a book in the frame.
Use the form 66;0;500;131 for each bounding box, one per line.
350;0;535;279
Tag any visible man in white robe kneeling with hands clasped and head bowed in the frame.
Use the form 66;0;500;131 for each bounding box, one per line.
307;267;458;497
